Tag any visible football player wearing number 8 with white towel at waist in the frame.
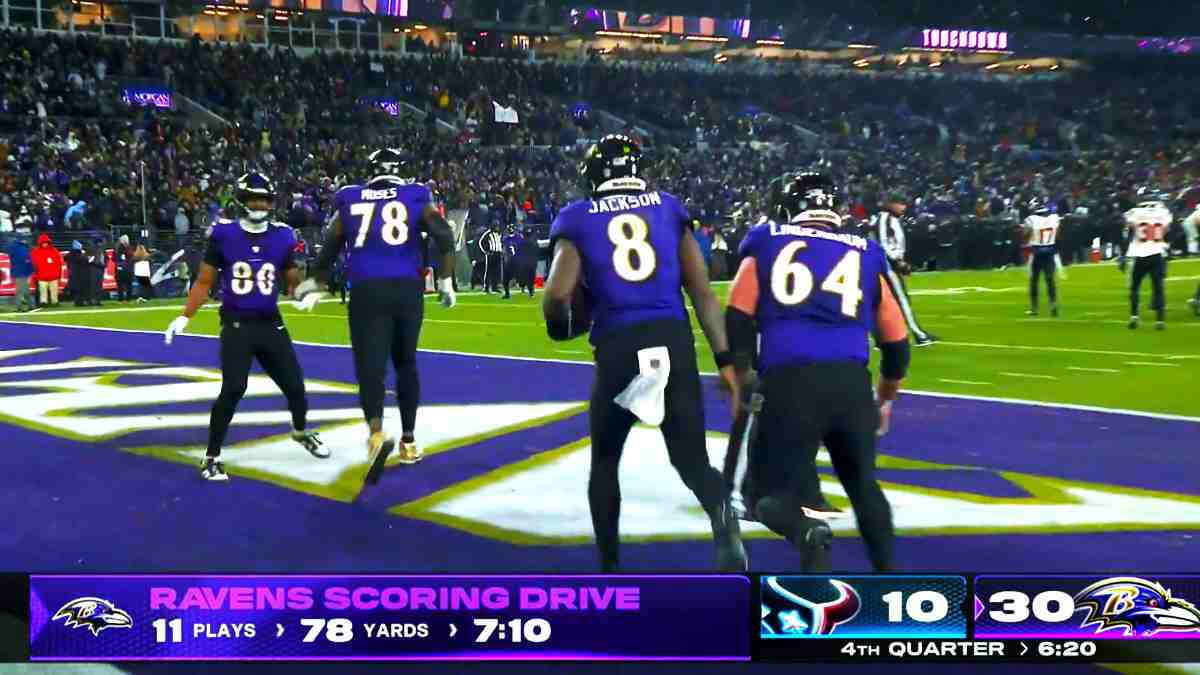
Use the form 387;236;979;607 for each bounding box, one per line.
542;135;746;572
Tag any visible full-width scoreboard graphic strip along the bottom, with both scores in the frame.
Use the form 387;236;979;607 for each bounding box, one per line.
7;574;1200;663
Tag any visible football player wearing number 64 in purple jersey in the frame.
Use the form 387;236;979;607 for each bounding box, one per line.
726;173;910;572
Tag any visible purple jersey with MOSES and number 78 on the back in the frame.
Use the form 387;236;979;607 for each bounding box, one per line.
334;178;433;283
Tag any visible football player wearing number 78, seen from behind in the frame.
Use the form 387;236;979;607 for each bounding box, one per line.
296;148;455;484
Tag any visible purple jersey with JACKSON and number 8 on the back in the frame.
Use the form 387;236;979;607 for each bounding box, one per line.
550;191;691;344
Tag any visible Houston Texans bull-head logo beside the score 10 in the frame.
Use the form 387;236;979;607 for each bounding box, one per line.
760;577;863;637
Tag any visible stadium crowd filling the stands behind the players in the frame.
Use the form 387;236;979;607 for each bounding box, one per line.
0;31;1200;279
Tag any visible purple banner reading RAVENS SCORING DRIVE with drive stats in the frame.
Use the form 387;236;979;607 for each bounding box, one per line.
29;575;750;661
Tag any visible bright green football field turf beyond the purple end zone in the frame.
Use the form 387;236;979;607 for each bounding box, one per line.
0;258;1200;417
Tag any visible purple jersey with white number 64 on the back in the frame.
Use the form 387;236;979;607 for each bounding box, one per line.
740;221;888;372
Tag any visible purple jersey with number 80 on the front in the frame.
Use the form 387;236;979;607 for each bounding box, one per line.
204;220;296;318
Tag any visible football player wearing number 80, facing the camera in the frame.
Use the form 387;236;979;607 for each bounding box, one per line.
163;173;329;480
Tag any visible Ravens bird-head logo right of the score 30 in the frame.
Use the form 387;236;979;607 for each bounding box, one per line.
1075;577;1200;637
